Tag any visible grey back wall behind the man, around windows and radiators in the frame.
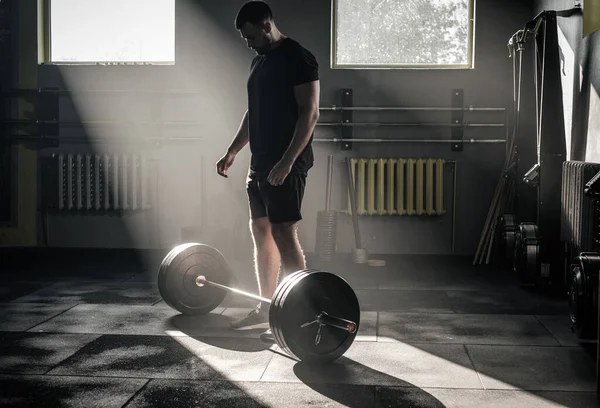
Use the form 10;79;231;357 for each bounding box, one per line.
39;0;535;255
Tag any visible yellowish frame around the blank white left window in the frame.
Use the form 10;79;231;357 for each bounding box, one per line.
38;0;177;66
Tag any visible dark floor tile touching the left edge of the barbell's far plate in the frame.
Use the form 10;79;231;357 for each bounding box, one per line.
14;282;161;305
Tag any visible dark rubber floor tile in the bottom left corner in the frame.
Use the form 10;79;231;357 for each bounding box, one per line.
0;375;148;408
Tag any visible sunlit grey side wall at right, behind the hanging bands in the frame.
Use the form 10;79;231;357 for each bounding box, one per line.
535;0;600;162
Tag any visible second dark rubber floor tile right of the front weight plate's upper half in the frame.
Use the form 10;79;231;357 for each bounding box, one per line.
446;291;569;315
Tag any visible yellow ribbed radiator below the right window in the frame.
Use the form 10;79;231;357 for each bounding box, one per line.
346;158;446;215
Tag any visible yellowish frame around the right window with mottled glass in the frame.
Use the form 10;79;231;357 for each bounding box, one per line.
330;0;476;70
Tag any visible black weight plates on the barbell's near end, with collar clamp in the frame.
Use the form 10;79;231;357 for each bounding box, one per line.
273;271;360;363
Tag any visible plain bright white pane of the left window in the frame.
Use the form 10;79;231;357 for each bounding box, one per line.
47;0;175;64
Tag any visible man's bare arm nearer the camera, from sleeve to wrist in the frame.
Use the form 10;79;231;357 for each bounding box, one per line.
282;80;320;166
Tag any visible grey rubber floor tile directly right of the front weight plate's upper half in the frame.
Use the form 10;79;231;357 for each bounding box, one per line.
355;290;454;313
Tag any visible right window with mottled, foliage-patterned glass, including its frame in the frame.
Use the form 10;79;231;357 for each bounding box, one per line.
331;0;475;69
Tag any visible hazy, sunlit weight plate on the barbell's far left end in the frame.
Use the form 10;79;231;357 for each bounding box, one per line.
158;243;232;315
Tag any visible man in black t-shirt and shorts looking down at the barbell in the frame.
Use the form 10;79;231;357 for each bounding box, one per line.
217;1;320;342
